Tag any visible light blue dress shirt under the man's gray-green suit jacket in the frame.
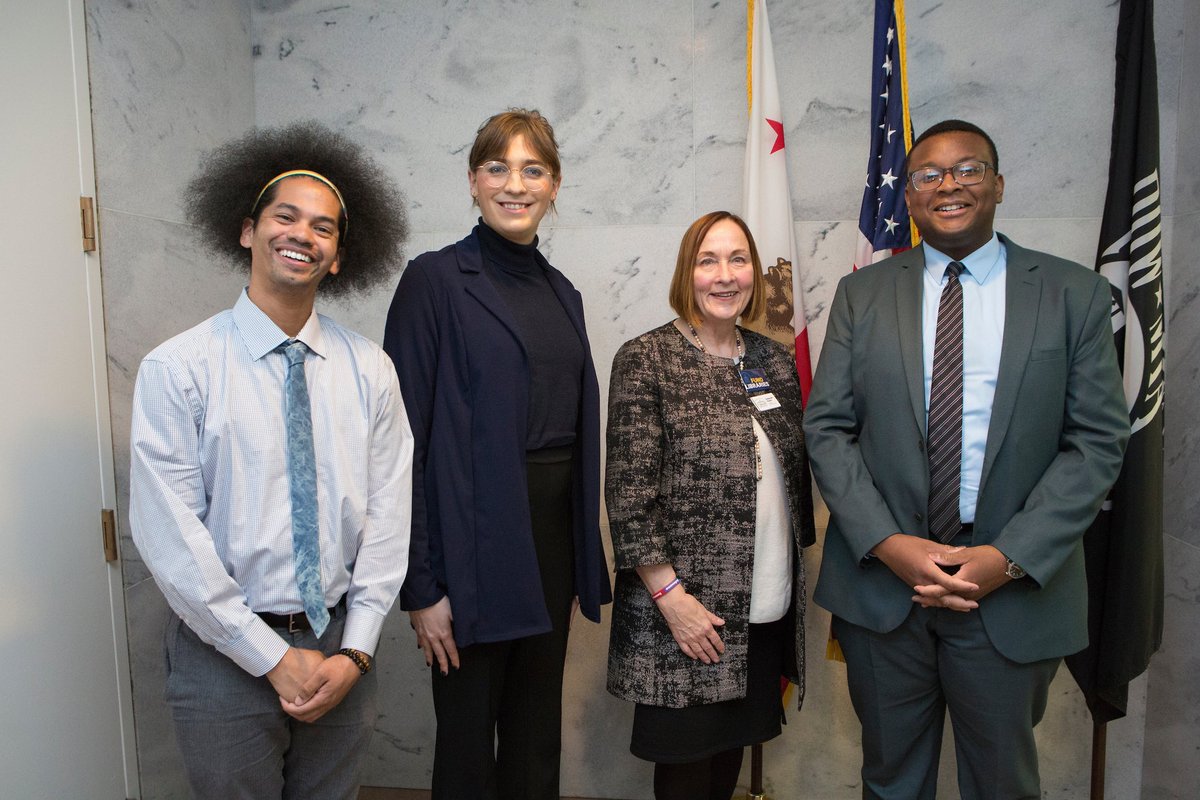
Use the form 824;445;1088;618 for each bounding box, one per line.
920;233;1008;524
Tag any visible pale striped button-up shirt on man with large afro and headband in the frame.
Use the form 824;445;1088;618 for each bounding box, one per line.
130;291;413;675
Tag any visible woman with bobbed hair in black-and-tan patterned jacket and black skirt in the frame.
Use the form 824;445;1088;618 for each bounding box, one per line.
605;211;815;800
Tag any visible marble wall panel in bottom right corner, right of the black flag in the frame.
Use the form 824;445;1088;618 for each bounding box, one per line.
1141;532;1200;800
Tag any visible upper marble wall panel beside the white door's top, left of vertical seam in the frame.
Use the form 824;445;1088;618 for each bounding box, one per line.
85;0;254;219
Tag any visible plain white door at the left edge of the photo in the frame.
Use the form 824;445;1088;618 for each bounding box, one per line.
0;0;138;800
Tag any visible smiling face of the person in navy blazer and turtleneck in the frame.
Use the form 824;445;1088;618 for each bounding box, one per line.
468;134;562;245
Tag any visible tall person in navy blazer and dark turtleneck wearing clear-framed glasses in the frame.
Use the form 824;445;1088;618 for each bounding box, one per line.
384;109;611;800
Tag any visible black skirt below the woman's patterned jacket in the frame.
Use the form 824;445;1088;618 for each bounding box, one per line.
629;614;792;764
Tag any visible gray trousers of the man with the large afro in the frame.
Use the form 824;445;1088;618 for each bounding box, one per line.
166;609;378;800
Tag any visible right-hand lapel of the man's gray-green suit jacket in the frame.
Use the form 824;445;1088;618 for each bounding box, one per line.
979;236;1042;492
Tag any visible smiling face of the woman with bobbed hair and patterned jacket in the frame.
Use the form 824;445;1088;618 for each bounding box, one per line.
691;219;755;327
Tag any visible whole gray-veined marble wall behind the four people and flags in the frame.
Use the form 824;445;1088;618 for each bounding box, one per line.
86;0;1200;800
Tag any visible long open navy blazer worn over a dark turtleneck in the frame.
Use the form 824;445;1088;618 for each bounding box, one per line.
383;231;612;648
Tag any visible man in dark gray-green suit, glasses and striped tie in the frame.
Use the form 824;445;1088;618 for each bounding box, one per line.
804;120;1129;800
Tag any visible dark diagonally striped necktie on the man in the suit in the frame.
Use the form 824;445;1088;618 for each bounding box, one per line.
928;261;965;542
